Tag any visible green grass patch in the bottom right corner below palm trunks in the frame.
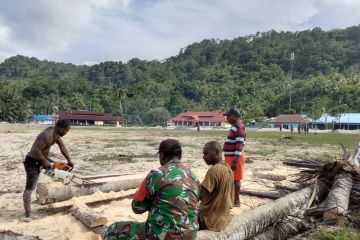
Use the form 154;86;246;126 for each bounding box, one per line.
315;226;360;240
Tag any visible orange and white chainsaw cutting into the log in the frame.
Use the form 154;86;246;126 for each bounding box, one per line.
41;162;96;185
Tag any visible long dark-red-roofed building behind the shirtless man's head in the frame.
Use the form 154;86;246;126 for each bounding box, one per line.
59;110;124;126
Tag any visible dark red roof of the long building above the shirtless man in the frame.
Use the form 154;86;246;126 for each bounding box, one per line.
59;110;124;122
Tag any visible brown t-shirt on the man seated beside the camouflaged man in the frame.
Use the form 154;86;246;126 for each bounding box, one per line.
200;163;234;231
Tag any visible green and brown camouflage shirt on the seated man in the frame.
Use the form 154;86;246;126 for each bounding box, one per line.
132;159;199;239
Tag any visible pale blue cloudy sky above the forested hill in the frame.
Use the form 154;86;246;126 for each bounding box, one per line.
0;0;360;65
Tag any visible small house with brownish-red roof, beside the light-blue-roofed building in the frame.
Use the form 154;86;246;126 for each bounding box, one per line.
270;114;309;129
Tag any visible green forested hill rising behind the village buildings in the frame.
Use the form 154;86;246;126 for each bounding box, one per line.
0;25;360;124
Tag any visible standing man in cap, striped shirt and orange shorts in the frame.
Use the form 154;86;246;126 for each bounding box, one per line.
223;108;246;207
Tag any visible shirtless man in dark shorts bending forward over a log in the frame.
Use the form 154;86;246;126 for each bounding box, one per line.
23;120;74;220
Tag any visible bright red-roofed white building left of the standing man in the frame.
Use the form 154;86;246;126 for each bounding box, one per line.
169;111;226;127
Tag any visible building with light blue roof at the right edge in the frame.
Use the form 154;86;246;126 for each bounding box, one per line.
313;113;360;130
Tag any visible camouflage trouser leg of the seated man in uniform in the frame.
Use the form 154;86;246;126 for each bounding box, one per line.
104;221;146;240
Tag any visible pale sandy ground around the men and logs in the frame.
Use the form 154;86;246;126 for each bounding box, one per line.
0;124;337;240
